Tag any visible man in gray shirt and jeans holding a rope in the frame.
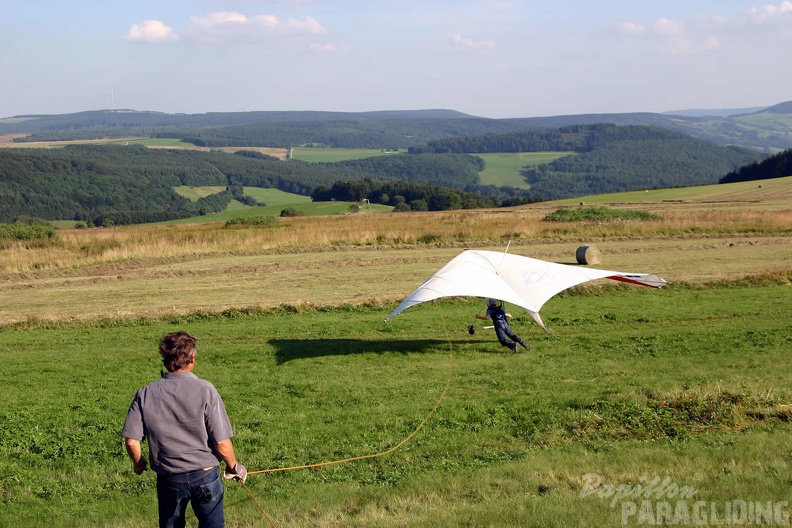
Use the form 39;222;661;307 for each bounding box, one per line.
121;332;247;528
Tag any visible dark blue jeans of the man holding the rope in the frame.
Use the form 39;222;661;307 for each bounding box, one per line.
157;467;225;528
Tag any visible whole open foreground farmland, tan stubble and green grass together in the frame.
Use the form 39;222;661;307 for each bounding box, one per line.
0;178;792;527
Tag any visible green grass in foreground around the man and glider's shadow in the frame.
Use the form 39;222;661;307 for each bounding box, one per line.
0;285;792;527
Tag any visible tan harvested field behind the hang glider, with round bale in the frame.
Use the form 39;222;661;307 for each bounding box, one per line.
0;178;792;324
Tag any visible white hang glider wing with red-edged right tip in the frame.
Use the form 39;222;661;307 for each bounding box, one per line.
385;249;668;333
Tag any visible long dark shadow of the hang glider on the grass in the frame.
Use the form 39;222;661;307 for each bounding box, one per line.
269;339;499;365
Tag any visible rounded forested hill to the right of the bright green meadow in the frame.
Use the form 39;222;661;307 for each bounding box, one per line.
410;124;764;199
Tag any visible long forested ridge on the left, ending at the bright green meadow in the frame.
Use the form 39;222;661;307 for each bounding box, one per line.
0;145;512;225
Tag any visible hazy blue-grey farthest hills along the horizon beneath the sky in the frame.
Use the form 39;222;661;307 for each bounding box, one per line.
0;101;792;154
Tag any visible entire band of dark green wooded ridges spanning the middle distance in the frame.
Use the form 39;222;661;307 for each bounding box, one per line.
0;125;763;225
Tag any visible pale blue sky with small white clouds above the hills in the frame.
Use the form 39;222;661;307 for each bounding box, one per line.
0;0;792;118
